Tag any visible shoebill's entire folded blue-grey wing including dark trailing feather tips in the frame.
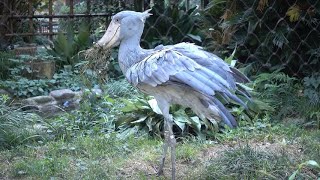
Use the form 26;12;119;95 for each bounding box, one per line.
126;43;250;127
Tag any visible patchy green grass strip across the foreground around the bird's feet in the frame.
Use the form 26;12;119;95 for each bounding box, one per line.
0;124;320;179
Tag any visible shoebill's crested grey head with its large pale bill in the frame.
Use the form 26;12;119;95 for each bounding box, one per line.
97;9;151;49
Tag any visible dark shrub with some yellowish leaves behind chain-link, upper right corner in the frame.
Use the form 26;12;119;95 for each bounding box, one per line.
201;0;320;77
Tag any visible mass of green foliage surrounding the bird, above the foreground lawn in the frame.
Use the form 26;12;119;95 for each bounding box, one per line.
0;0;320;153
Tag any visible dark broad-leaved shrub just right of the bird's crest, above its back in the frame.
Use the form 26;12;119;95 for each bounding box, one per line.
142;4;202;48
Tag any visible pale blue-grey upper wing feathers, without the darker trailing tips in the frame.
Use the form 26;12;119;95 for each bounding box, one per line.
126;43;245;95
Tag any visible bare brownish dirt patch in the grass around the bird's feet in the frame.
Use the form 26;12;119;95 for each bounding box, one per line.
119;140;303;179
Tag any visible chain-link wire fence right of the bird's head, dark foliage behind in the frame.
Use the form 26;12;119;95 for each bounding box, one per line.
144;0;320;77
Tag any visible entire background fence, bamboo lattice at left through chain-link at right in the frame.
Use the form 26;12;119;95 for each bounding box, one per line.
0;0;320;77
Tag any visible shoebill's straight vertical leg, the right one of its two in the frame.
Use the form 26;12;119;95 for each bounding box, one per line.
167;115;176;180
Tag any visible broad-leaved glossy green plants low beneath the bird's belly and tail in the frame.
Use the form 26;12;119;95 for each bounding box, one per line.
111;93;269;138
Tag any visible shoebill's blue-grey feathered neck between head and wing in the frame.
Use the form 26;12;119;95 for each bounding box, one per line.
118;36;144;73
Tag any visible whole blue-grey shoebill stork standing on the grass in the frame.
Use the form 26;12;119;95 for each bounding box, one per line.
95;10;248;179
